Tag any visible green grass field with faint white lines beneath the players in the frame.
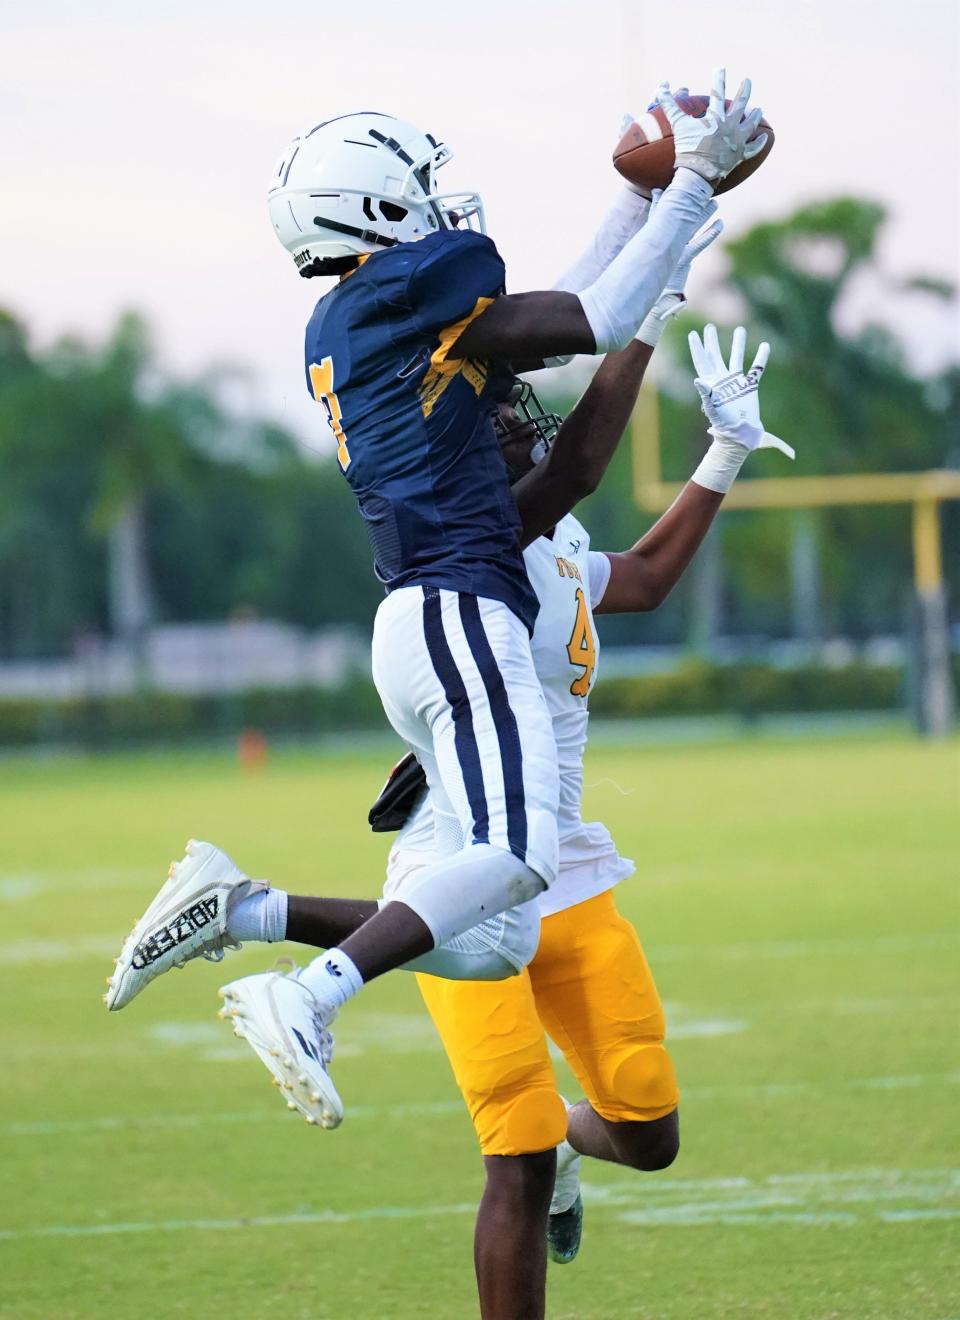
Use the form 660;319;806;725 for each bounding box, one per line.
0;737;960;1320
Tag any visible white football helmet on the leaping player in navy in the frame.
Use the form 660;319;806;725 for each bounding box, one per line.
268;111;486;276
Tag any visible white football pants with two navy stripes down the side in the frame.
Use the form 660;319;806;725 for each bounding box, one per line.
374;586;560;956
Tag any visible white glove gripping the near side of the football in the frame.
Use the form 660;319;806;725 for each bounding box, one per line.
656;69;767;183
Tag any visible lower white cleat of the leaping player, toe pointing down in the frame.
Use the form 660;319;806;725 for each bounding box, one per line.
219;966;343;1127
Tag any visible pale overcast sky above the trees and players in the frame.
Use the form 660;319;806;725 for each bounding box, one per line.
0;0;960;438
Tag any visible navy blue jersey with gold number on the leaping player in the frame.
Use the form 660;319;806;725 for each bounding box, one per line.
306;230;537;628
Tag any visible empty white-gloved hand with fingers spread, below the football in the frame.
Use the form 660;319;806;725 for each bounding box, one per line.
689;325;796;458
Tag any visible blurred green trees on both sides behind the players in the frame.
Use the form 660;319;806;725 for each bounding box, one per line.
0;198;960;659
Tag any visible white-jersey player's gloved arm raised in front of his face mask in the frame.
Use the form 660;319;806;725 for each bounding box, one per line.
514;209;724;545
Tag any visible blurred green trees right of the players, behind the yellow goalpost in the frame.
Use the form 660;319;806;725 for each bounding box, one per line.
559;198;960;649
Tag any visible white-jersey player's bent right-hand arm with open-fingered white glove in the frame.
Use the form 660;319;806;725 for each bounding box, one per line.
594;325;794;614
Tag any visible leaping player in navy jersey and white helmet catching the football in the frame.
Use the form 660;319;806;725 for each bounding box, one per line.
106;70;765;1125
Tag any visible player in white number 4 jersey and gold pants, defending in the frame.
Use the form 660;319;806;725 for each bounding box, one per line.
155;303;792;1320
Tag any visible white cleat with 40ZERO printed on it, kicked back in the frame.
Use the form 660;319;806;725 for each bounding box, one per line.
103;838;268;1010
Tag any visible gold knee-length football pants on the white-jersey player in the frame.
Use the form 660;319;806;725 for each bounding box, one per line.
417;891;680;1155
